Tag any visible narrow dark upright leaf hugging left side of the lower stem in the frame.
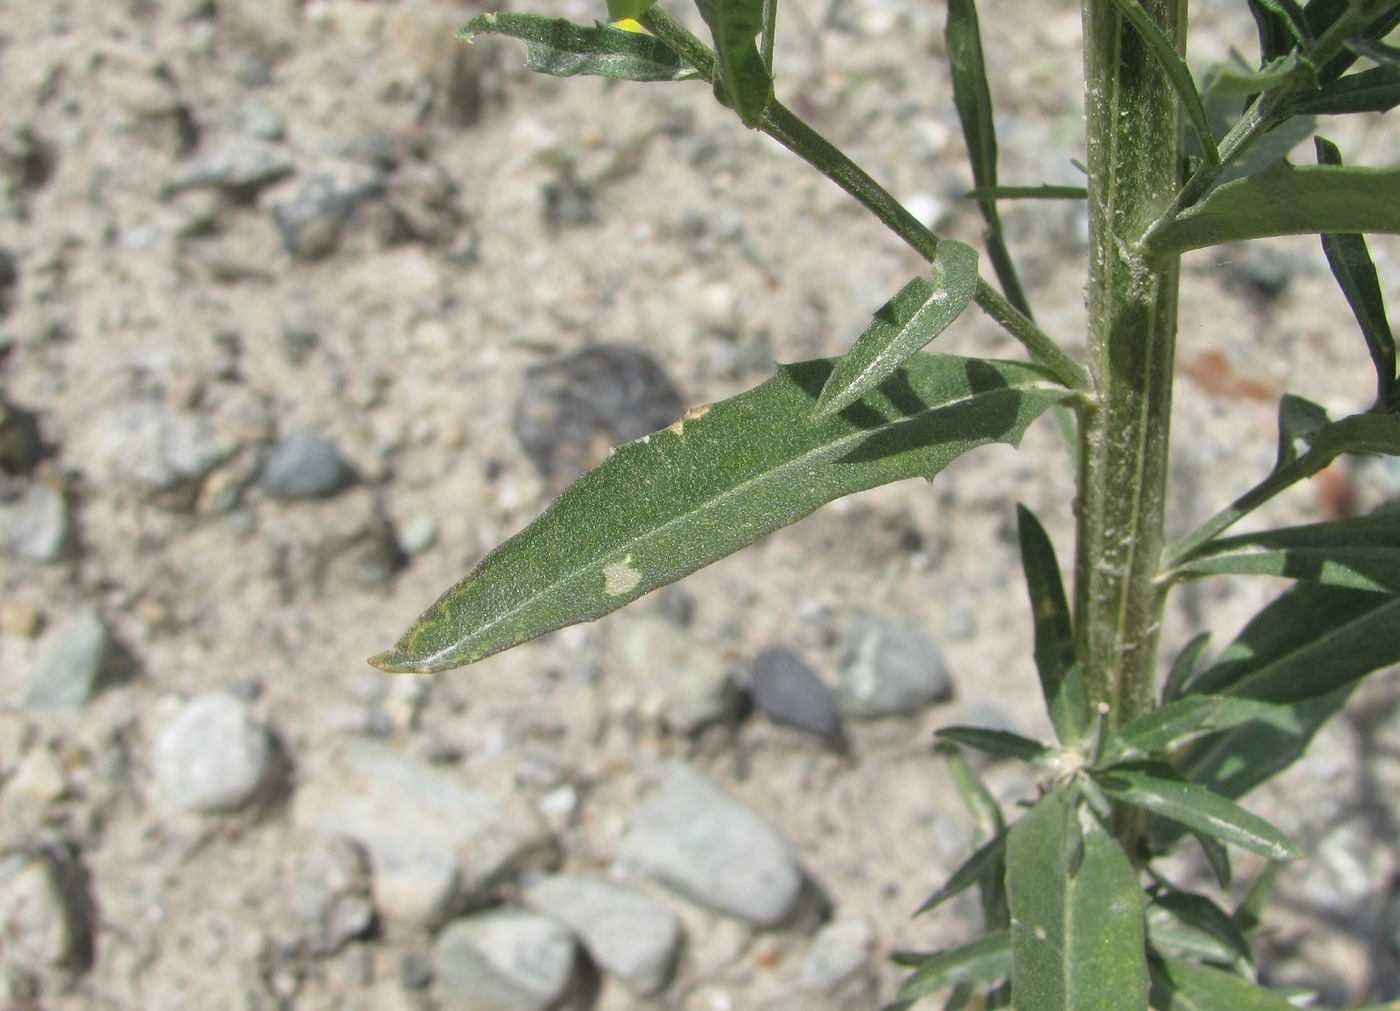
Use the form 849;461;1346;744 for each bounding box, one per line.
1016;506;1089;745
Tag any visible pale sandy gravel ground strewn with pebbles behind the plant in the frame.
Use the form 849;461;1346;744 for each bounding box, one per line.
0;0;1400;1011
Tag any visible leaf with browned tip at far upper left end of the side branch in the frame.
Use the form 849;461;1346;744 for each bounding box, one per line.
456;13;696;81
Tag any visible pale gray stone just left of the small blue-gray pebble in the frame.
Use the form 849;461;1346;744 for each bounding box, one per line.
92;400;230;501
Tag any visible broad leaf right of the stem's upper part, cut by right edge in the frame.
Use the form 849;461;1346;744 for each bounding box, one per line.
1147;161;1400;255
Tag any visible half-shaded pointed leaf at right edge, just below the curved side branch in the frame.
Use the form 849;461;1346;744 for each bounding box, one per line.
1177;508;1400;594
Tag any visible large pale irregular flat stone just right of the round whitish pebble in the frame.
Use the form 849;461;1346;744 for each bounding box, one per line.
294;741;547;927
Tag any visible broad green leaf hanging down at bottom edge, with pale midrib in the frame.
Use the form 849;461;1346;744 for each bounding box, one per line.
1007;790;1148;1011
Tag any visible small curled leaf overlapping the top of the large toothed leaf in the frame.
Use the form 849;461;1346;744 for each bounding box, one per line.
813;239;977;419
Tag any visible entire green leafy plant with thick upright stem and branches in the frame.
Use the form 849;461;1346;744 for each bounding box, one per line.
371;0;1400;1011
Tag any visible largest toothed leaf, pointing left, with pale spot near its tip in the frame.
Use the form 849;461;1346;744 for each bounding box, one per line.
371;354;1067;674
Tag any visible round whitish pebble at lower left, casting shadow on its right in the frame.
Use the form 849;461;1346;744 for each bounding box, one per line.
154;692;273;812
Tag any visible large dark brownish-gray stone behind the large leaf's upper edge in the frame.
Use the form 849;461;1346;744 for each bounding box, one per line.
515;344;685;489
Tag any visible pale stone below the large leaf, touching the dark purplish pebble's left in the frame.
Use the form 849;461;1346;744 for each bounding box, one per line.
622;618;735;734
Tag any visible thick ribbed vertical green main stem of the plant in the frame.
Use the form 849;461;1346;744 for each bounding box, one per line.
1075;0;1187;750
